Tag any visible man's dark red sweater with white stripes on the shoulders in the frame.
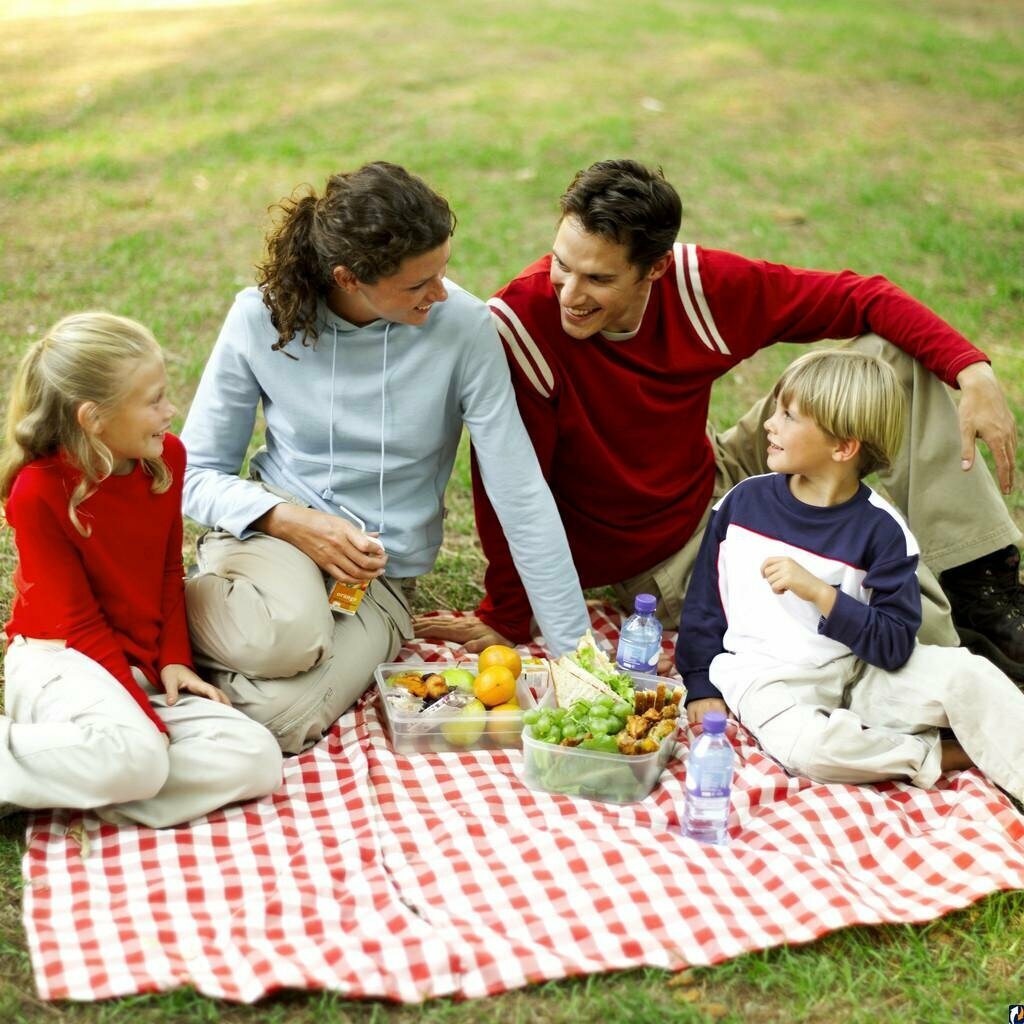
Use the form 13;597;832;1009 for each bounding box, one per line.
473;244;986;641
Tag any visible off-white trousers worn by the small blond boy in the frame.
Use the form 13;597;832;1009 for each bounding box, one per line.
729;644;1024;800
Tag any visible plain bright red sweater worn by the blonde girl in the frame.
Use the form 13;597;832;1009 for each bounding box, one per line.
5;434;193;732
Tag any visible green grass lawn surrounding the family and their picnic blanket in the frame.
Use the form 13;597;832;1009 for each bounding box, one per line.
0;0;1024;1024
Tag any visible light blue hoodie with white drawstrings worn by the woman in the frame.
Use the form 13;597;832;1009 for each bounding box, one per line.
181;281;590;653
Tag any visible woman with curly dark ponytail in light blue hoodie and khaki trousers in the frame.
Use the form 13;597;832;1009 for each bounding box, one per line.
182;162;588;753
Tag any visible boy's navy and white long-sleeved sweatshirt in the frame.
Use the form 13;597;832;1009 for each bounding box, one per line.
676;473;921;709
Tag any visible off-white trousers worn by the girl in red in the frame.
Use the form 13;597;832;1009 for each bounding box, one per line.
0;637;281;828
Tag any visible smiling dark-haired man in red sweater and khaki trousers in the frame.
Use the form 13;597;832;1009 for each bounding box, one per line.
417;160;1024;679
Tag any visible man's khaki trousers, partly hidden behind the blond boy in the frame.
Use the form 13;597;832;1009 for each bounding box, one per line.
615;334;1021;647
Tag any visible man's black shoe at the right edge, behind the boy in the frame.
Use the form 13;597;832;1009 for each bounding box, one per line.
940;545;1024;682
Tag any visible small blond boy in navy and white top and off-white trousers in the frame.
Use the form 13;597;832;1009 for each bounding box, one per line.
676;350;1024;800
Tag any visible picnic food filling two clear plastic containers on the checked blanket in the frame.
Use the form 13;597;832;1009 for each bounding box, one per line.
377;631;683;803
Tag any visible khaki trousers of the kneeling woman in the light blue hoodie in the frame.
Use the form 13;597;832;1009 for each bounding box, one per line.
185;530;413;754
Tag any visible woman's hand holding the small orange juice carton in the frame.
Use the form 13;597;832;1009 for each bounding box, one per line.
253;502;387;583
